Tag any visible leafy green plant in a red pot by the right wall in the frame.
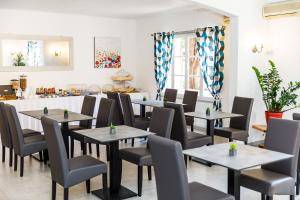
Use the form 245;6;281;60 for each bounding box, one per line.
252;60;300;123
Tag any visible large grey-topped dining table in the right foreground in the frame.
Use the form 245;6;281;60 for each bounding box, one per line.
183;143;293;200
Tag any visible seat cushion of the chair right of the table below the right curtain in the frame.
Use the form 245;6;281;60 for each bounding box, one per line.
214;127;248;141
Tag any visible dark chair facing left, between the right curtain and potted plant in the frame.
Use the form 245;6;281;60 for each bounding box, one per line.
214;97;254;144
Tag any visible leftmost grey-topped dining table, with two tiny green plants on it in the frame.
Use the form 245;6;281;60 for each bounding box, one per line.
19;109;95;158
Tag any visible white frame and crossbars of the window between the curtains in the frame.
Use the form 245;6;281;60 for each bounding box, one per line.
169;34;213;102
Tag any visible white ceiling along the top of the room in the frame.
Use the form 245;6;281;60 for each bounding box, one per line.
0;0;204;18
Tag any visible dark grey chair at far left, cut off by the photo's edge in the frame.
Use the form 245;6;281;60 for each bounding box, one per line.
0;102;42;167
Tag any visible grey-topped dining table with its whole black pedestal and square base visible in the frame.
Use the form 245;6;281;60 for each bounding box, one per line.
74;125;154;200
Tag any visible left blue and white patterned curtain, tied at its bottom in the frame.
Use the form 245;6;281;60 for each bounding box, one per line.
154;32;174;100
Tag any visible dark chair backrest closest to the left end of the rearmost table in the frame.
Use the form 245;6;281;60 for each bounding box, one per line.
120;94;134;126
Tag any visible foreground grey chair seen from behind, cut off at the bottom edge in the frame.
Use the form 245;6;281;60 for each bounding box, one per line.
149;135;234;200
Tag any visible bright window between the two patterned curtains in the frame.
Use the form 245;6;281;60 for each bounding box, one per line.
167;35;212;98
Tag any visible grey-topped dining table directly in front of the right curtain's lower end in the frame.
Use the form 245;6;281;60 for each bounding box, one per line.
184;111;243;144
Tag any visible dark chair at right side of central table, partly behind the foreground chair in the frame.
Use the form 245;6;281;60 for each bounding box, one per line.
120;108;174;196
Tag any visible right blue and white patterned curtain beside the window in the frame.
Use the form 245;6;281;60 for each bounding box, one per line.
196;26;225;127
